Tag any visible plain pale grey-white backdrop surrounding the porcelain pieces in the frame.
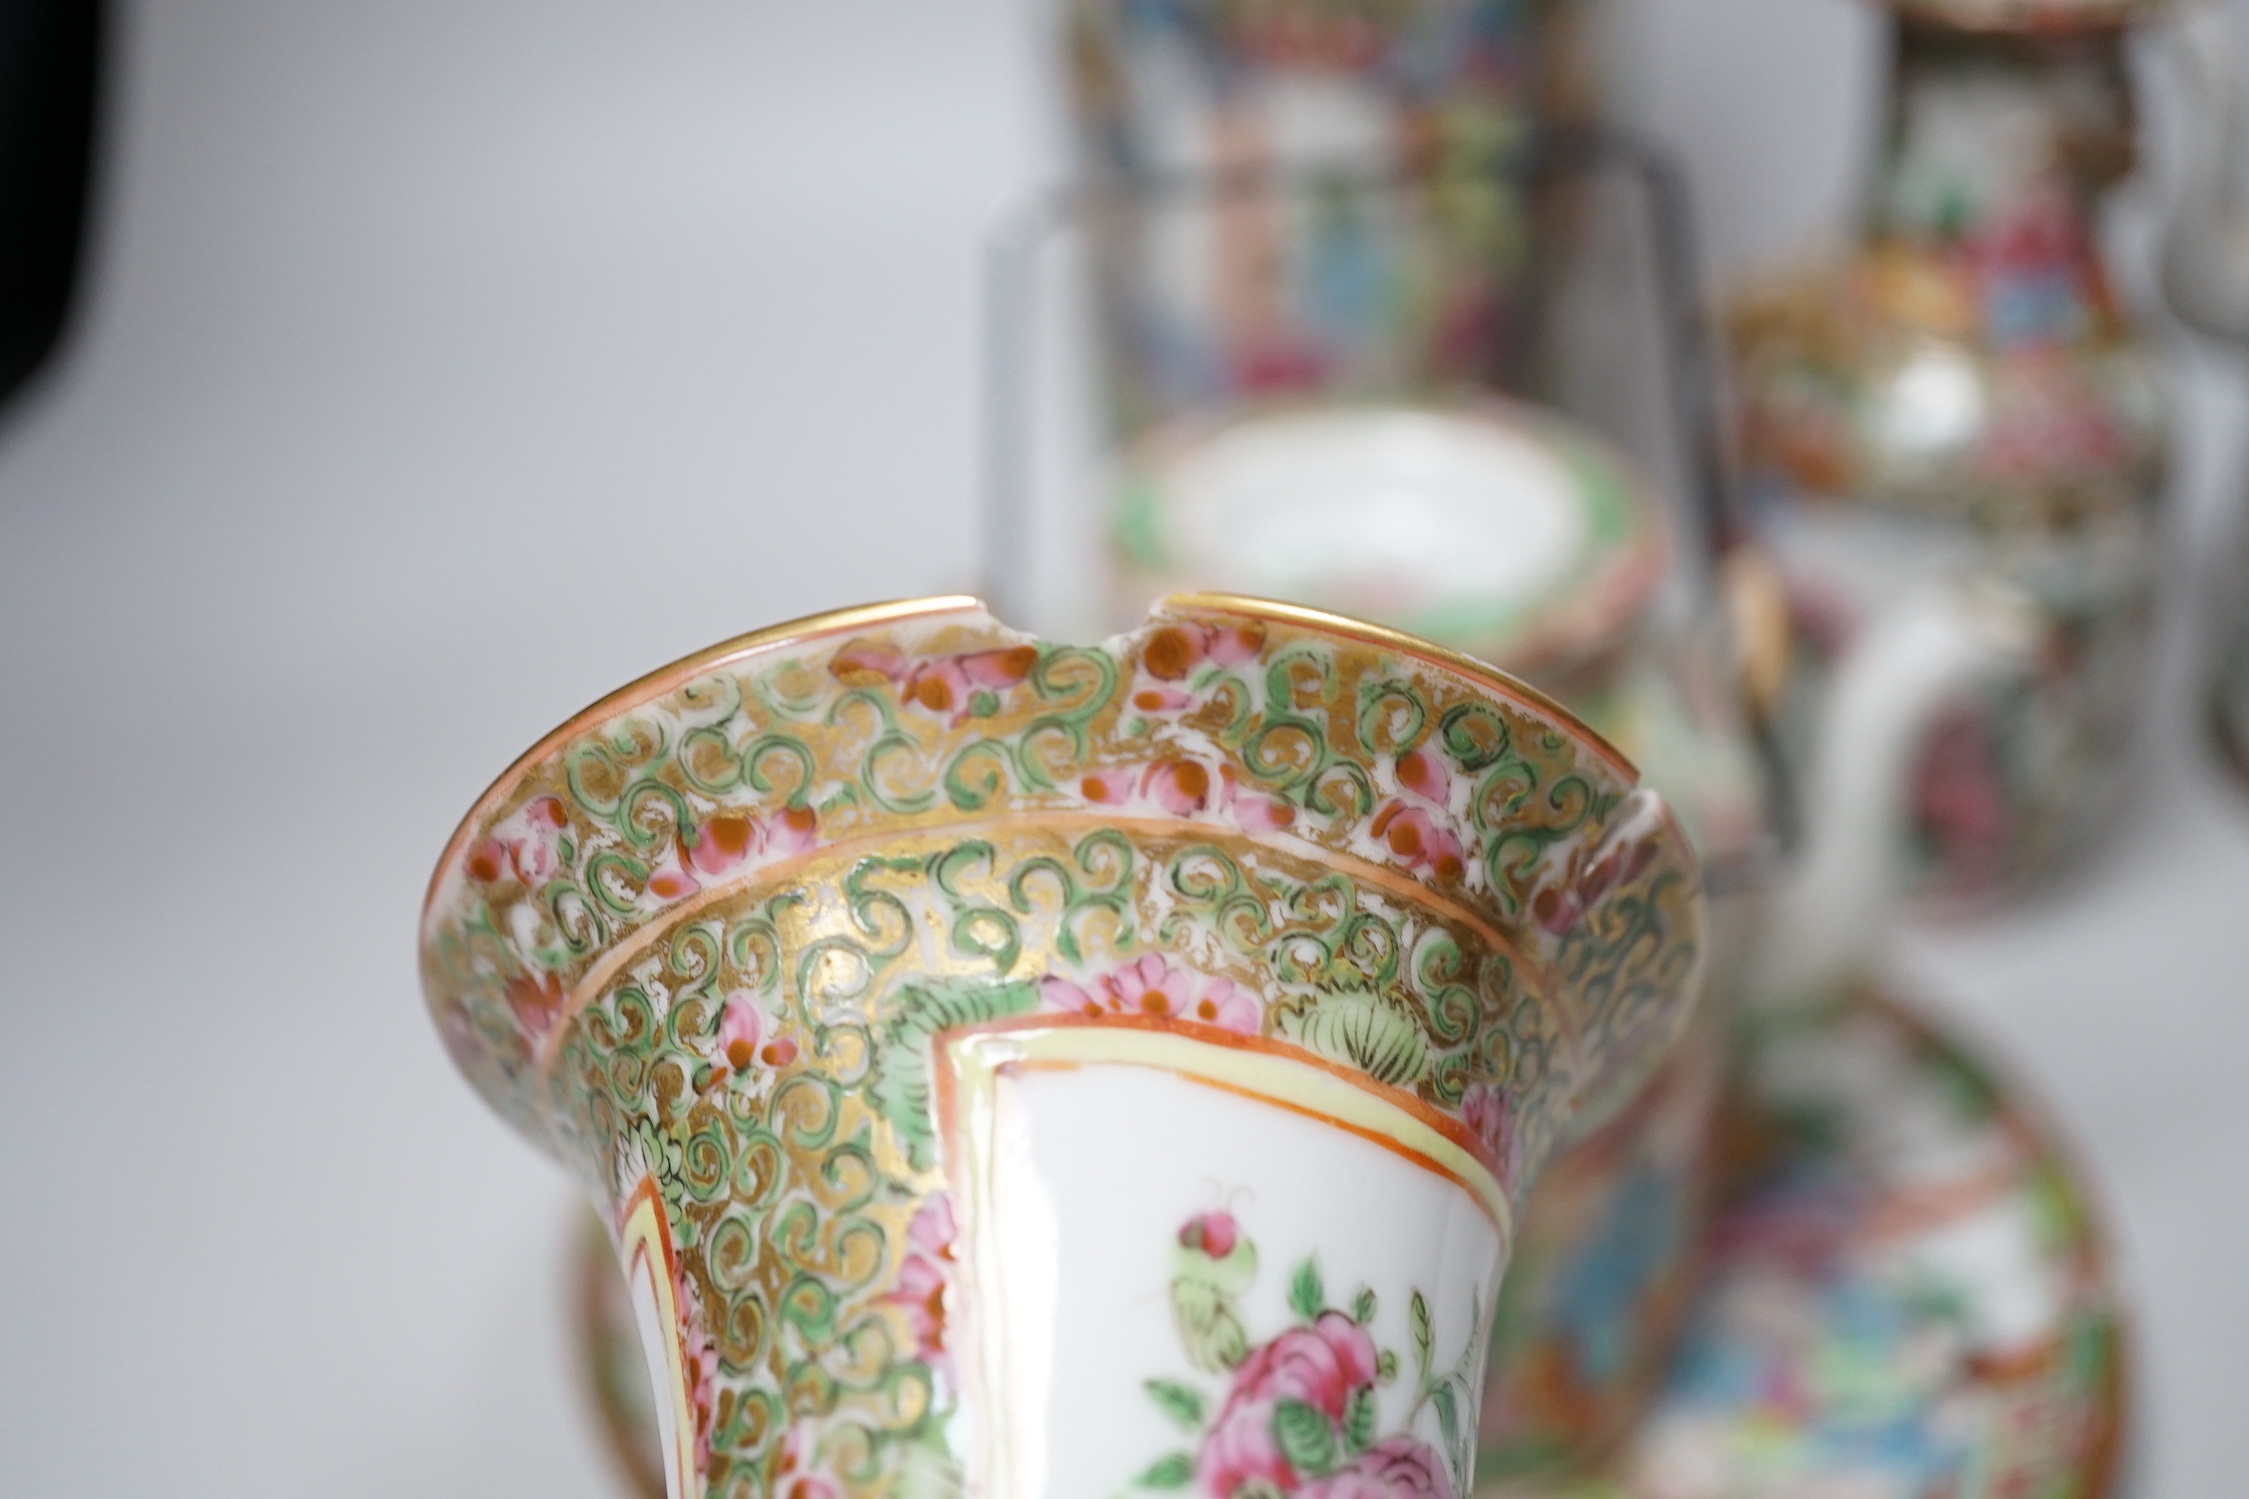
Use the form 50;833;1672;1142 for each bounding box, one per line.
0;0;2249;1499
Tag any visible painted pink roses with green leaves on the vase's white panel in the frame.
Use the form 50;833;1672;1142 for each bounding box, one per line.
1133;1211;1482;1499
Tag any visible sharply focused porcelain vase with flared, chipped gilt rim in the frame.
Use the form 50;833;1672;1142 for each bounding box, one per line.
421;596;1705;1499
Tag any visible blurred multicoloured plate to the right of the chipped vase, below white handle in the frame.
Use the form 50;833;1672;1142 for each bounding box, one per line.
1484;996;2123;1499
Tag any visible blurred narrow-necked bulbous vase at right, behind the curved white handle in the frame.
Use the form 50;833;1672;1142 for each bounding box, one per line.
1732;0;2170;906
